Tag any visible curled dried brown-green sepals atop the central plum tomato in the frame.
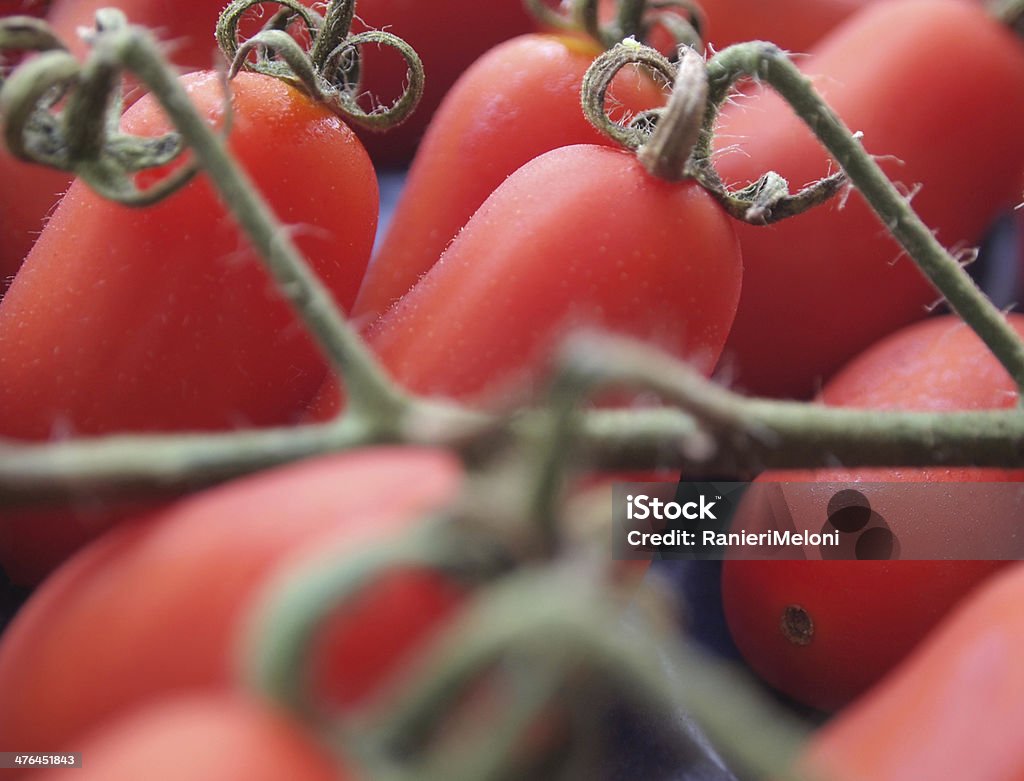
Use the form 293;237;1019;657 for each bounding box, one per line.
582;41;848;225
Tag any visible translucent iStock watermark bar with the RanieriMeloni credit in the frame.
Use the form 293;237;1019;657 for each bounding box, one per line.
612;481;1024;561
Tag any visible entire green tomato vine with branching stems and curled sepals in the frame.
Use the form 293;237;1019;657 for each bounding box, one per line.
0;0;1024;778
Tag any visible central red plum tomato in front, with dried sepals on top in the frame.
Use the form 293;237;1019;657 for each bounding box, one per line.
314;144;741;417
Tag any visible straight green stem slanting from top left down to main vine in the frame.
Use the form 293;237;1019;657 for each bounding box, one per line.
97;28;409;425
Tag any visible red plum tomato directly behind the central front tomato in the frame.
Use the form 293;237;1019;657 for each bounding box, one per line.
353;35;665;317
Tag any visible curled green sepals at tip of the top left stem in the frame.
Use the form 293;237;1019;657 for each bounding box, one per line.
0;9;224;206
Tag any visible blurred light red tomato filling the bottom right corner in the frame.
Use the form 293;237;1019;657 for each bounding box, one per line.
802;564;1024;781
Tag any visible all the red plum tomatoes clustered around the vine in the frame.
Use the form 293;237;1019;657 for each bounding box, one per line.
0;0;1024;781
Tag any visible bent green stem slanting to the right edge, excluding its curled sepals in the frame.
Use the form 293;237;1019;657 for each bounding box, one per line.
697;41;1024;397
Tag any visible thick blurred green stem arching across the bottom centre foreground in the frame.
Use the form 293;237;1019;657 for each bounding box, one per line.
367;568;806;779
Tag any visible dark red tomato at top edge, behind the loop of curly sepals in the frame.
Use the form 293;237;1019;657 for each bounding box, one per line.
352;0;536;166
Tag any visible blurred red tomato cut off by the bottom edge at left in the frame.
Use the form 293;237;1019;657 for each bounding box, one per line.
32;695;357;781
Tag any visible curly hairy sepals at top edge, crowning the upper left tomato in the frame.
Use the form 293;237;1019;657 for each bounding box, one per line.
217;0;425;130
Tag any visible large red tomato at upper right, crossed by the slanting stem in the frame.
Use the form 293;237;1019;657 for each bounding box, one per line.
718;0;1024;397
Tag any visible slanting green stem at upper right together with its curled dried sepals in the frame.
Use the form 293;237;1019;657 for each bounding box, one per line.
583;41;1024;397
